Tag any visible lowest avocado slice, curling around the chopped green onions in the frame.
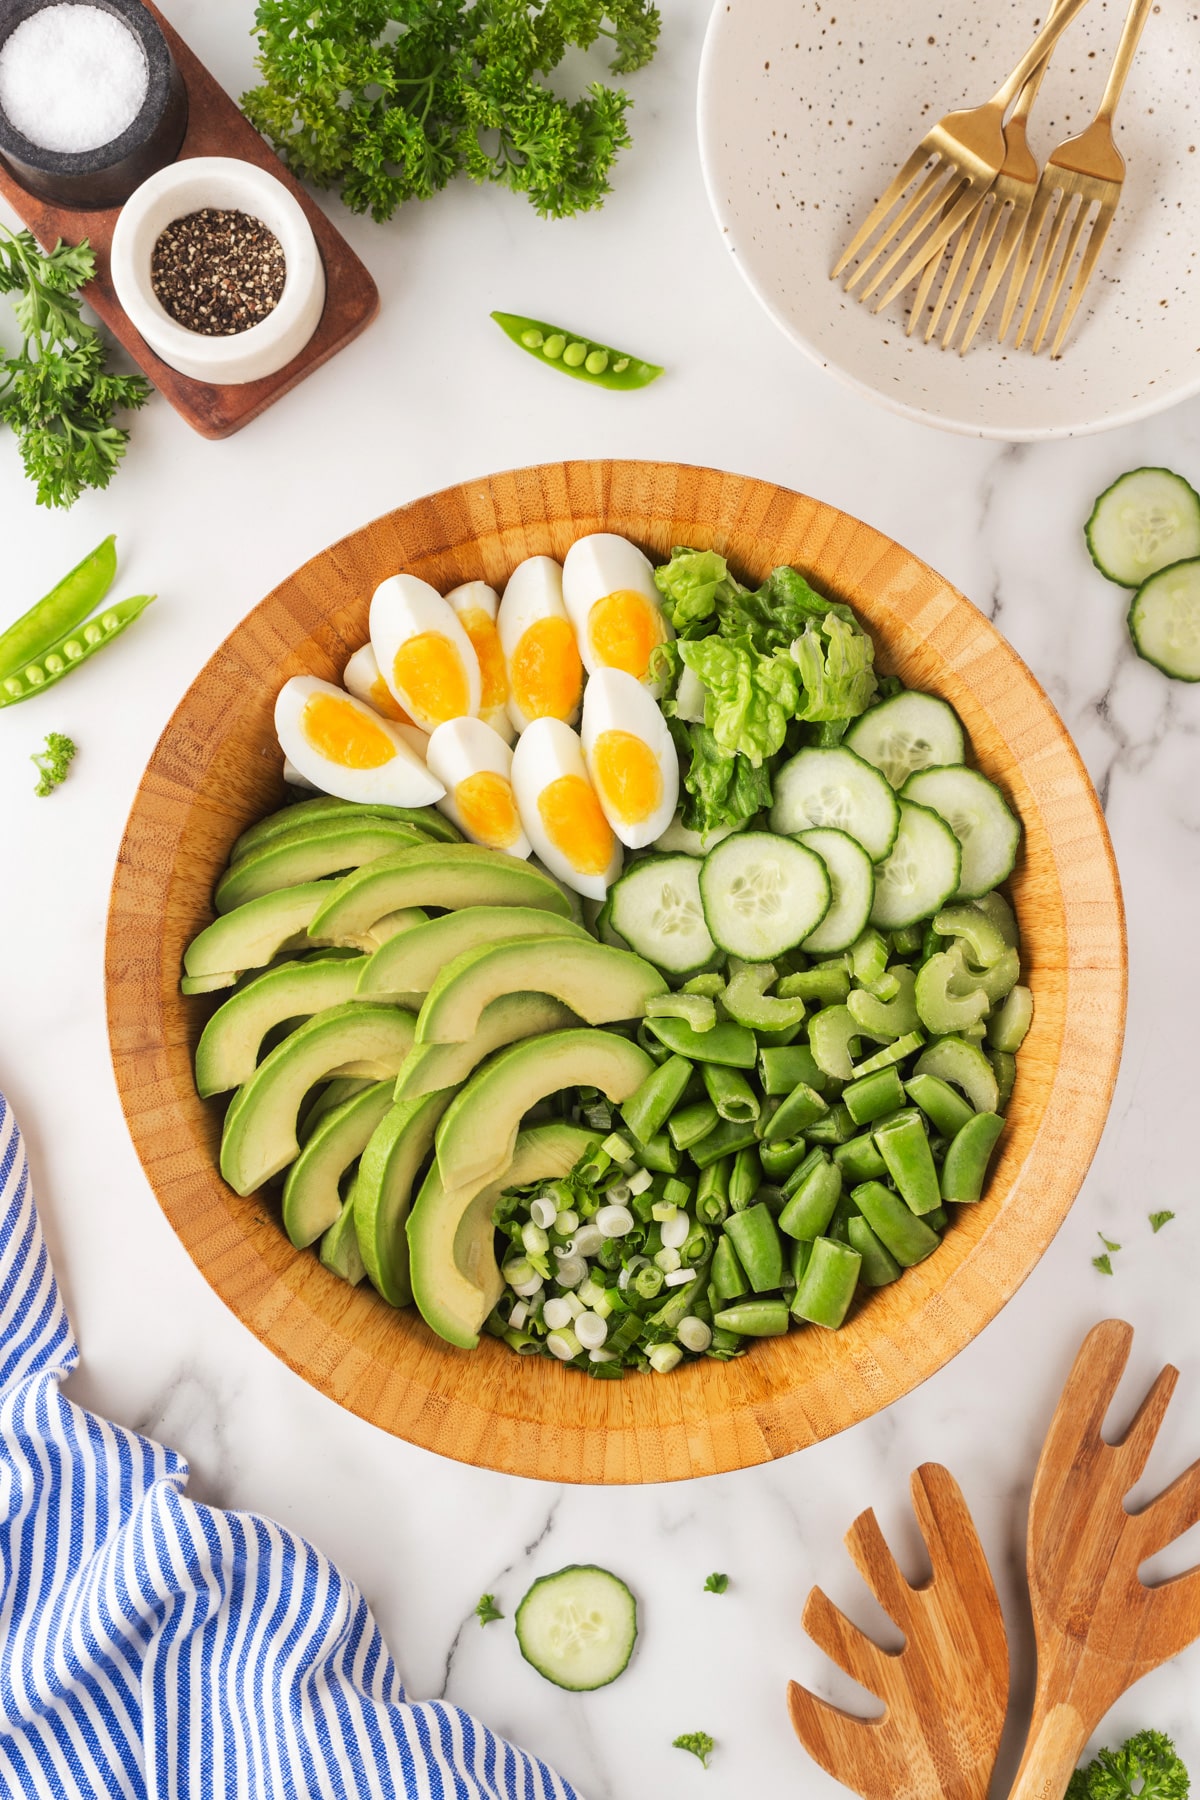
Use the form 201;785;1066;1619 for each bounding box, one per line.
408;1121;597;1350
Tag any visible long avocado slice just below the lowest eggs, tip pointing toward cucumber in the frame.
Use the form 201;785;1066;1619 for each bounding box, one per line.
309;844;570;950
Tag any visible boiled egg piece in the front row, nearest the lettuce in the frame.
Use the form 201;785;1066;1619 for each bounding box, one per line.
579;670;678;850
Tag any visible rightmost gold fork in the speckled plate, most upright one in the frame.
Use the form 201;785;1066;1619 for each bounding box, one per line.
1000;0;1155;356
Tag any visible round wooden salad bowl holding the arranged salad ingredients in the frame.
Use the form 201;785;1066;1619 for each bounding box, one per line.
108;463;1126;1481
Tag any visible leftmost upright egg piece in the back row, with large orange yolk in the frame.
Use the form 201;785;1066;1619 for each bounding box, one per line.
371;574;482;731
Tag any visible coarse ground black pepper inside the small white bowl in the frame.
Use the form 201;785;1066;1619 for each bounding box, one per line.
149;207;288;337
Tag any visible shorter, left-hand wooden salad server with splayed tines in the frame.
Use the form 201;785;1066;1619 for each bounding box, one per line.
788;1463;1007;1800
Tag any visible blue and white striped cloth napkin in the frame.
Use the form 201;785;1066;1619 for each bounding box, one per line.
0;1094;576;1800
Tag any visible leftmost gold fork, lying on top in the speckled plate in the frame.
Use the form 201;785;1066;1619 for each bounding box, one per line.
831;0;1087;311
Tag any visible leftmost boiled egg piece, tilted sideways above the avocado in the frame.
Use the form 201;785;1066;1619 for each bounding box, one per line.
275;675;444;806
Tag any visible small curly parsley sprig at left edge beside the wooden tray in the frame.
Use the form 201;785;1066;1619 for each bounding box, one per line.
0;225;151;506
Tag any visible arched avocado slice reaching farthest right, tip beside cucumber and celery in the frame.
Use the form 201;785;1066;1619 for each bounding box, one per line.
417;927;667;1044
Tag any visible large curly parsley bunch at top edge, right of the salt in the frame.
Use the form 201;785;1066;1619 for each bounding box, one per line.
241;0;660;220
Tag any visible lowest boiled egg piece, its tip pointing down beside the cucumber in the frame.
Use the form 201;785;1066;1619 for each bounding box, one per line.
513;718;621;900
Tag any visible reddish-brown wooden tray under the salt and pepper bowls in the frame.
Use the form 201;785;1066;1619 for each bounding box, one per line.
0;0;380;437
